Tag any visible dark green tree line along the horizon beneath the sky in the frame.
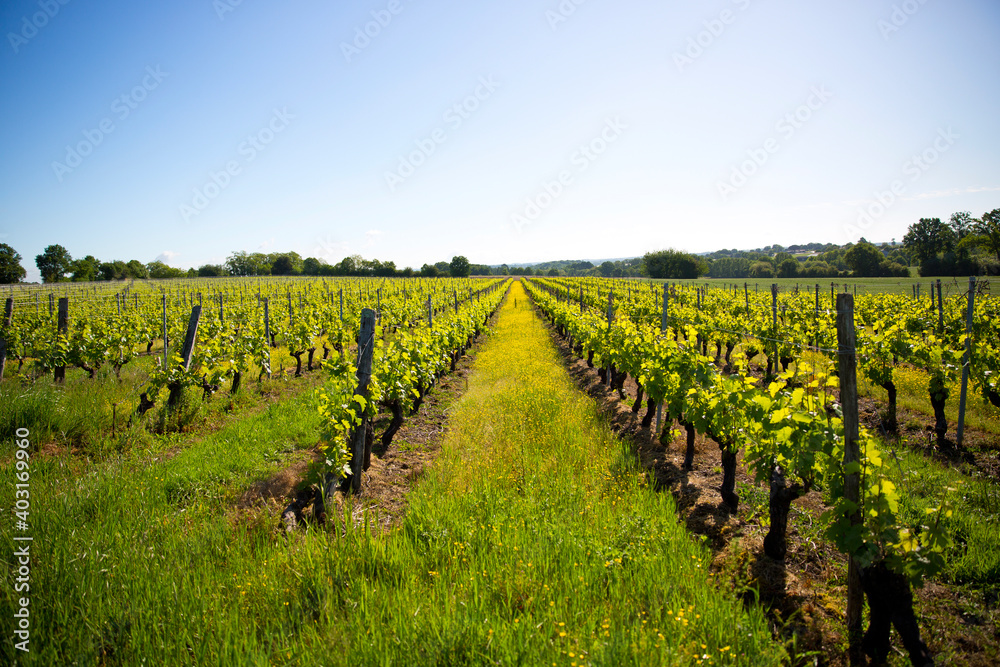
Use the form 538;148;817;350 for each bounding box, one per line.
0;209;1000;284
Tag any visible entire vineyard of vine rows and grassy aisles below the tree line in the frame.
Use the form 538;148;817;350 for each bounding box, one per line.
0;277;1000;665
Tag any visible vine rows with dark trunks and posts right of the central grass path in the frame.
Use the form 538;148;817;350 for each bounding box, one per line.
529;279;1000;665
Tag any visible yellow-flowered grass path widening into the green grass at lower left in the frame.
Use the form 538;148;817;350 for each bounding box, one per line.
0;283;782;665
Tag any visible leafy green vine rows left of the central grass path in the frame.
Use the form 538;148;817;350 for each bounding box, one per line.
0;280;502;457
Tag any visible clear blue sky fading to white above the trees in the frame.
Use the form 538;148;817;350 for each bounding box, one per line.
0;0;1000;280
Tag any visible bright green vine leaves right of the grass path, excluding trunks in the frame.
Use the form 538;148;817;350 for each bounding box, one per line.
529;279;980;584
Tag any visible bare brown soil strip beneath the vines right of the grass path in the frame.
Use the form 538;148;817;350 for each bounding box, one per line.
540;313;1000;667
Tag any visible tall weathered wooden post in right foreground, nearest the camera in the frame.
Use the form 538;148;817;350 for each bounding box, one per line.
837;293;865;667
